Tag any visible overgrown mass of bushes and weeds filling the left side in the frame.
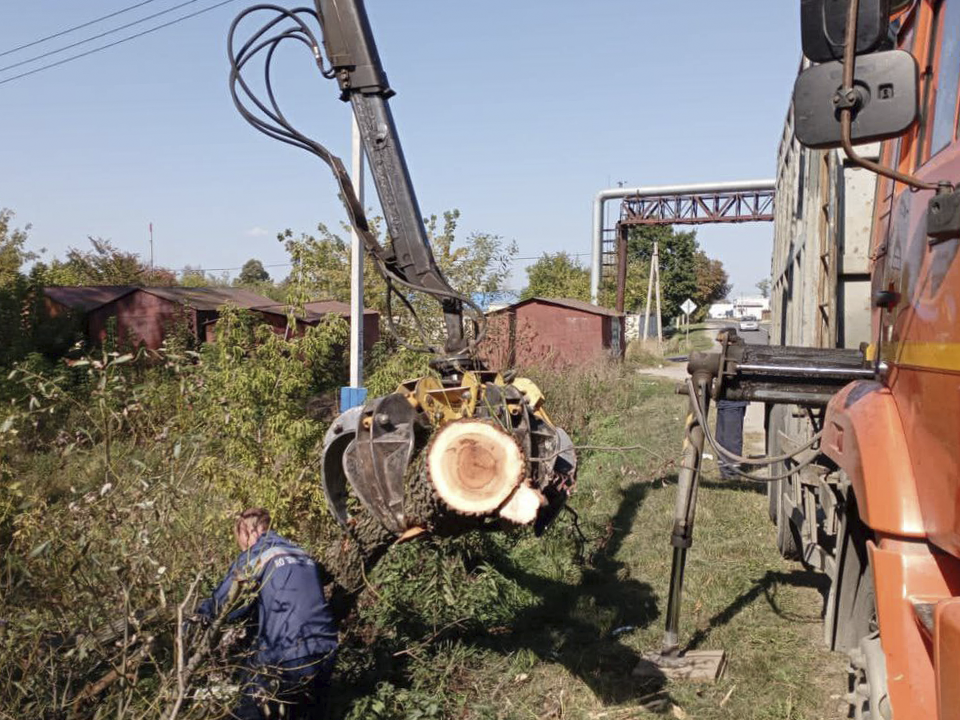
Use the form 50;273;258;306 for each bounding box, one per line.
0;311;354;718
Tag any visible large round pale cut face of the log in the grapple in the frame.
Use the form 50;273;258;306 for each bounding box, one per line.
427;420;524;515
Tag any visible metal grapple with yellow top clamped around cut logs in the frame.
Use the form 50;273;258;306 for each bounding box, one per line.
322;371;577;538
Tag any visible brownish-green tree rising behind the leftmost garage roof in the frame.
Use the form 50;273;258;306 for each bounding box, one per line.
46;237;177;287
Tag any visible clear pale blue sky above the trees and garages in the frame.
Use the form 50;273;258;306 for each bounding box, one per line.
0;0;800;293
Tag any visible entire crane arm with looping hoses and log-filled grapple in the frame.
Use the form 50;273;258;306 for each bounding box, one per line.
229;0;577;572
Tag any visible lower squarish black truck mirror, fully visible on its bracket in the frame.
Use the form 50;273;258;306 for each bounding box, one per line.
793;50;920;148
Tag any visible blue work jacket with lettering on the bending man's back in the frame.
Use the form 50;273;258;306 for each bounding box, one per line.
197;530;337;666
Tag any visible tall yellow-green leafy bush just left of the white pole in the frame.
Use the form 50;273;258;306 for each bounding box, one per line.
199;309;349;531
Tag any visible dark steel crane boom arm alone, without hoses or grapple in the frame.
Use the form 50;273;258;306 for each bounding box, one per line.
317;0;466;356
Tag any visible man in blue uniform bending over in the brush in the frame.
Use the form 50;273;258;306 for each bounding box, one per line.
197;508;337;720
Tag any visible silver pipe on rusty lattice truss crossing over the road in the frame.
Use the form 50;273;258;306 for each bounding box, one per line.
590;180;776;305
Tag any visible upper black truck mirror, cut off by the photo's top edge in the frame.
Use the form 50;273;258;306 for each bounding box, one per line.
800;0;893;63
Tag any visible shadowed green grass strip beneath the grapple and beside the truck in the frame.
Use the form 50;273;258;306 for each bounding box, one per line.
326;376;844;720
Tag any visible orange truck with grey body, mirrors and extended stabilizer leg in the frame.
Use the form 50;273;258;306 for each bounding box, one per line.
663;0;960;720
